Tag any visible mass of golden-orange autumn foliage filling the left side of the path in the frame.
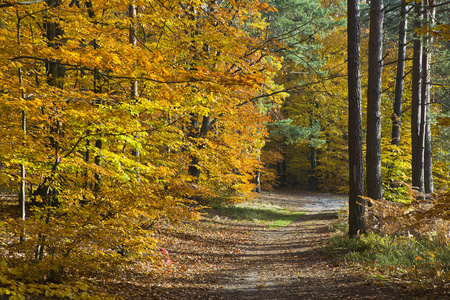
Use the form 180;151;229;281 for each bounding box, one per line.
0;1;283;292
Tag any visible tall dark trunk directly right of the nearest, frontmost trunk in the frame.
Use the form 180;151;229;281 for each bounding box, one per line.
366;0;383;199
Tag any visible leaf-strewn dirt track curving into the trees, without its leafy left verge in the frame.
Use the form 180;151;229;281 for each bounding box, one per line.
209;189;401;299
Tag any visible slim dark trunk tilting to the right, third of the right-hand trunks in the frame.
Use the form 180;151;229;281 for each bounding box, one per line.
391;0;407;146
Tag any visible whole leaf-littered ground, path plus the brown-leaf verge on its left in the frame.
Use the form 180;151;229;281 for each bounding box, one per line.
95;189;448;300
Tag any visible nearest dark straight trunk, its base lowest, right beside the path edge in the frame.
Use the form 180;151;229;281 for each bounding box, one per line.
347;0;366;237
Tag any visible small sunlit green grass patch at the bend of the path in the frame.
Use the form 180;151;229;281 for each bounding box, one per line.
212;203;306;228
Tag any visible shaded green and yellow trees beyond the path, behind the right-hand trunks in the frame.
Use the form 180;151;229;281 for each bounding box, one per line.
266;2;449;199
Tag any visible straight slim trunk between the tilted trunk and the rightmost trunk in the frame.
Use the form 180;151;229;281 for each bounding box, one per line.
411;2;424;192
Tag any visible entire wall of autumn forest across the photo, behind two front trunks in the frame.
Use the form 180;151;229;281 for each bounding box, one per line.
0;0;450;294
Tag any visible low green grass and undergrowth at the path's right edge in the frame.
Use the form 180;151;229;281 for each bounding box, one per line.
325;210;450;288
